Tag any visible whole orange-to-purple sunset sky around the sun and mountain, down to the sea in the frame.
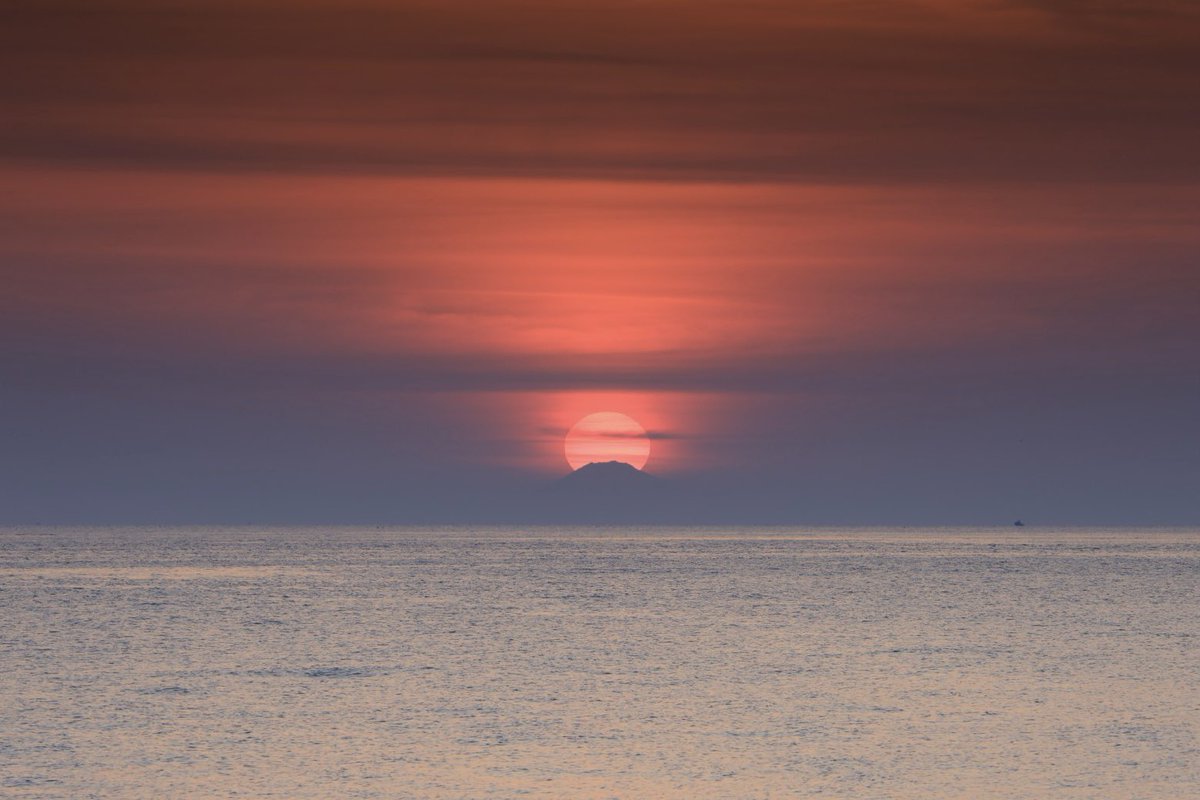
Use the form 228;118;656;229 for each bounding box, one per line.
0;0;1200;525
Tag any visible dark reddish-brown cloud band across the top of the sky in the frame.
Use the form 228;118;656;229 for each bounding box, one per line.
0;0;1200;184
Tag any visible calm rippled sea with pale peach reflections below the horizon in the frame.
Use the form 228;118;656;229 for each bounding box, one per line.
0;528;1200;800
